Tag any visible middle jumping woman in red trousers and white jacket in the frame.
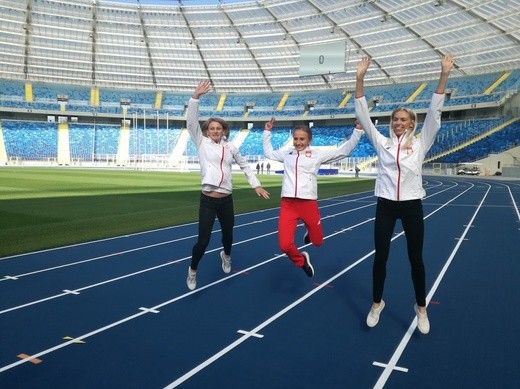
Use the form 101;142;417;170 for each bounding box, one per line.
263;118;363;277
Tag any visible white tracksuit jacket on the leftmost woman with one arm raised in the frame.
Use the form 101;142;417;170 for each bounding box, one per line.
186;98;261;194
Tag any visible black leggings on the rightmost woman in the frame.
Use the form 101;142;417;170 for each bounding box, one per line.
372;197;426;307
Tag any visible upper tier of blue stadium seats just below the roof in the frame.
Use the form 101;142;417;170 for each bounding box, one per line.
0;70;520;118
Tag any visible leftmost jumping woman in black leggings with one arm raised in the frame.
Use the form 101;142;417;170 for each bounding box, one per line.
186;81;269;290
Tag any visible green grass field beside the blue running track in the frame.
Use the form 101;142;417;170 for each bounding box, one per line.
0;167;374;257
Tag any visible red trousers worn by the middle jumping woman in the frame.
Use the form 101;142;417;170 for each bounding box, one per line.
278;197;323;267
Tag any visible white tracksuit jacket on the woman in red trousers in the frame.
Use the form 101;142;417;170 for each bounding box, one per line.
264;129;363;200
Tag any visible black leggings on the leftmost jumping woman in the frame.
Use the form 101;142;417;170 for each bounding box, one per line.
190;193;235;270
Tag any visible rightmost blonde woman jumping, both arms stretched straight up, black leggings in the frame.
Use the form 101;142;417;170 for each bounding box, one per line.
355;55;454;334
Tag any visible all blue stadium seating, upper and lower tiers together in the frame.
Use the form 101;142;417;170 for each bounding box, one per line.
0;70;520;166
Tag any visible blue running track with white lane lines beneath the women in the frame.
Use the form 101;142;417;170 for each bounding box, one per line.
0;176;520;389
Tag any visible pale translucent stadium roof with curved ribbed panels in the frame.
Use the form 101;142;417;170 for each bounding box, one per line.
0;0;520;93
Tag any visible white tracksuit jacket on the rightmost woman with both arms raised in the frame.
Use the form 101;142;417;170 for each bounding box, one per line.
355;93;444;201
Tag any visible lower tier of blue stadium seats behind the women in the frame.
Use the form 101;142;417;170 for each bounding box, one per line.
2;114;520;163
